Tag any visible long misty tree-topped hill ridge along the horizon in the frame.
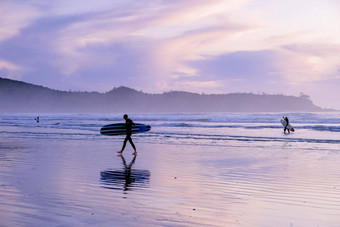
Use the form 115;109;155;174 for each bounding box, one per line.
0;78;325;113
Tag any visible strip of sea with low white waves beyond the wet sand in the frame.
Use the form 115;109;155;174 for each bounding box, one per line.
0;112;340;150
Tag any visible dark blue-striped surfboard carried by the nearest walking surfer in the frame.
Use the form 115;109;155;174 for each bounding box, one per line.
100;123;151;136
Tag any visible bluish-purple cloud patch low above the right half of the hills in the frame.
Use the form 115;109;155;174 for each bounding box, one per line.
183;50;283;92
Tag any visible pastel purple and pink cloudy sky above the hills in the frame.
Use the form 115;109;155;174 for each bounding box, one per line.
0;0;340;109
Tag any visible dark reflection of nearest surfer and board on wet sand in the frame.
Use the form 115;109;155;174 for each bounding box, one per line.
100;156;151;191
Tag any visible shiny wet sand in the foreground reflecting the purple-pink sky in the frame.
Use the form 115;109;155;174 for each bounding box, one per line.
0;138;340;226
